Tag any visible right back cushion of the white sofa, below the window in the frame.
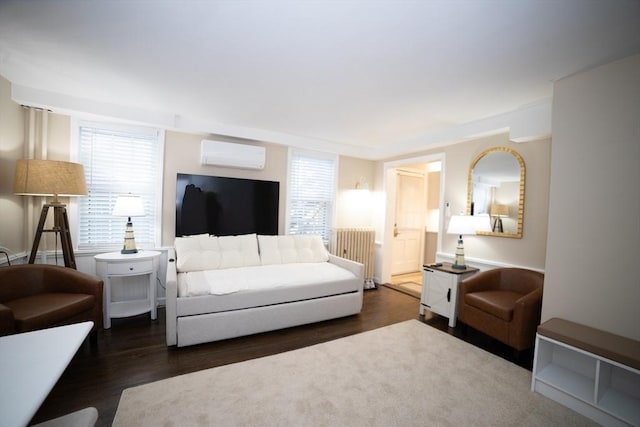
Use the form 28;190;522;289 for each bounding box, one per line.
258;235;329;265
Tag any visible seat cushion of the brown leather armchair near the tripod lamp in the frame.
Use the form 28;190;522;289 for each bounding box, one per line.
4;293;95;332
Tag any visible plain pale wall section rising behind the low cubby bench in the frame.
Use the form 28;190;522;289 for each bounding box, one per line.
542;55;640;340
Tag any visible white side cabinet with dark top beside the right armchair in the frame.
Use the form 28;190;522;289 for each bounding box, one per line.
420;262;479;328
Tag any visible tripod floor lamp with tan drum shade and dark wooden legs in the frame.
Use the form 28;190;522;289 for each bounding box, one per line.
13;159;87;268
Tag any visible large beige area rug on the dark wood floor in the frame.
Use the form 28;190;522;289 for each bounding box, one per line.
114;320;596;427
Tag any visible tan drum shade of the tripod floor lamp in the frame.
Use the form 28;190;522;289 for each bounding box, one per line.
13;159;87;199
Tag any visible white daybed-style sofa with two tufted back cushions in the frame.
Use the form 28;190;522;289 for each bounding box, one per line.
166;234;364;347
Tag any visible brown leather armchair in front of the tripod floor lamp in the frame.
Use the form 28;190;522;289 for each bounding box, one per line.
0;264;103;337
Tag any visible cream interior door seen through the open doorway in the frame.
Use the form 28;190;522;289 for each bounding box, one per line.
391;171;425;275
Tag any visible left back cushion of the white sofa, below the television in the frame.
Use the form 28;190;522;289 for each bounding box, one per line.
175;234;260;272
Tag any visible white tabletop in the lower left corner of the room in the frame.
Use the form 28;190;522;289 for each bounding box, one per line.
0;322;93;427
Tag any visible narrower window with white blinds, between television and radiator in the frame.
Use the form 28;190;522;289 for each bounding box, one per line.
287;149;337;244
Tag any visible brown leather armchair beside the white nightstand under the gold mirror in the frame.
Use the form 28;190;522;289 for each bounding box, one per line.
458;268;544;351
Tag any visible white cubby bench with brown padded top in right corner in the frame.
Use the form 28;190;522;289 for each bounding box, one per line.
531;318;640;426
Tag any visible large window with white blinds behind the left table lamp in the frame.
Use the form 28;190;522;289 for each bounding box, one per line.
77;122;164;249
